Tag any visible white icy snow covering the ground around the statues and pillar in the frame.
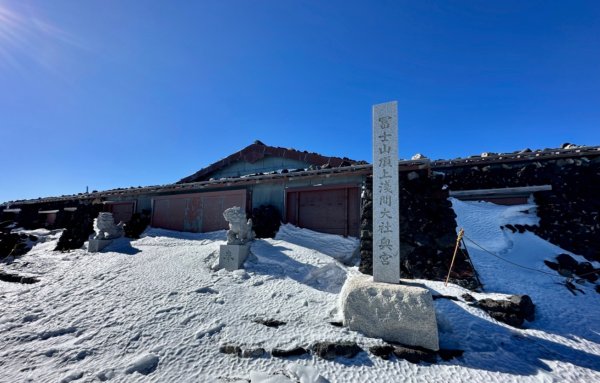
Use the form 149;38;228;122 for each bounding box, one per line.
0;208;600;383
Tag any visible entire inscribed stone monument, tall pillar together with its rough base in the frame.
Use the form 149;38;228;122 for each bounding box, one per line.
340;102;439;350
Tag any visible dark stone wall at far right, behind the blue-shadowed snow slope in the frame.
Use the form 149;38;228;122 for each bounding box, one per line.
433;152;600;261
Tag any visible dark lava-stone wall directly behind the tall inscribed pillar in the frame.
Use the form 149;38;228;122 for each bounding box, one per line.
360;169;478;289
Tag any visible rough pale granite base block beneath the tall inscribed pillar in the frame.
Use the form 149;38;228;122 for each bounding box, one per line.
340;275;439;351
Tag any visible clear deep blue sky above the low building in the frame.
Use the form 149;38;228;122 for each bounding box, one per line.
0;0;600;201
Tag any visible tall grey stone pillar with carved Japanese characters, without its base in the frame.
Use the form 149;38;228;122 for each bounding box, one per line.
373;101;400;283
